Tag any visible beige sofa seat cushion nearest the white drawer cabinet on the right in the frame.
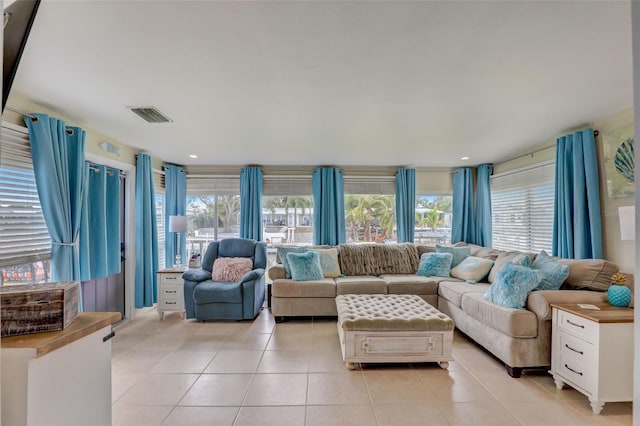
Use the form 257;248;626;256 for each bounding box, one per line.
462;292;538;338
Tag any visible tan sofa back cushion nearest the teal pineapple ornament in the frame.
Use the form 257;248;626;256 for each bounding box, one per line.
556;258;618;291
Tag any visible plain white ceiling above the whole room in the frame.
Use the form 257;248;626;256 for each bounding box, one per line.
7;0;633;167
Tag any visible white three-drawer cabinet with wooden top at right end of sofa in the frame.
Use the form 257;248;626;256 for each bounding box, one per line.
550;303;633;414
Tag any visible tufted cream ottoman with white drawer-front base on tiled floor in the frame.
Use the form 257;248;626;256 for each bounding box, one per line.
336;294;454;369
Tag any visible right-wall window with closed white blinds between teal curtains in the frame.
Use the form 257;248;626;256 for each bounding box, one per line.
491;162;555;253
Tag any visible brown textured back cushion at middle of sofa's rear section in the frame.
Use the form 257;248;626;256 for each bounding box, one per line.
338;243;420;276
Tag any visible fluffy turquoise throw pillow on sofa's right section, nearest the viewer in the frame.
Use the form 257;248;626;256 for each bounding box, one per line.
483;261;542;309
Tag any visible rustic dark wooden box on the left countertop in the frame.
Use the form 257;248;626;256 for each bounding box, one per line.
0;281;80;337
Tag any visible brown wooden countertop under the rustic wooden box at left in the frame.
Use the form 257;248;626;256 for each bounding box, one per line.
0;312;121;358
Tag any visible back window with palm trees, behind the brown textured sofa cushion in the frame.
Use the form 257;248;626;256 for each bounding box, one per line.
344;176;397;243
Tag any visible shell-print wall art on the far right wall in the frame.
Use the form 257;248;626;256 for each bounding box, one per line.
602;126;635;198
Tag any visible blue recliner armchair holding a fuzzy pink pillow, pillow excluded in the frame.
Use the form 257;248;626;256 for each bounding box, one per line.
182;238;267;320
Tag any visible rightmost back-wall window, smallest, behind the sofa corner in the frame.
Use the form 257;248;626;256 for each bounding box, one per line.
414;195;453;245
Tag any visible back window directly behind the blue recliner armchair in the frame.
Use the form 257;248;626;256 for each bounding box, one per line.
187;175;240;259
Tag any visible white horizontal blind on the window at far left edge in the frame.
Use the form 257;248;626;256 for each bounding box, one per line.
0;124;51;267
